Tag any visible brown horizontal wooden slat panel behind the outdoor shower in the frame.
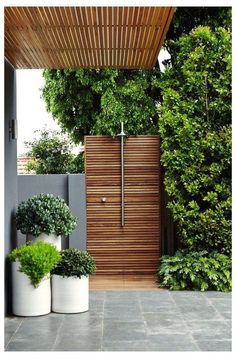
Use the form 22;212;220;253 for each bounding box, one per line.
85;136;161;274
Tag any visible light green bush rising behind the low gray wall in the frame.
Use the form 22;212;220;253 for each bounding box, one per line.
26;129;84;174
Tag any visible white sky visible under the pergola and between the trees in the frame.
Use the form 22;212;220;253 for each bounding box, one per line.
16;50;169;156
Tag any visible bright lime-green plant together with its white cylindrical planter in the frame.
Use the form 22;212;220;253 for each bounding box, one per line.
8;241;61;316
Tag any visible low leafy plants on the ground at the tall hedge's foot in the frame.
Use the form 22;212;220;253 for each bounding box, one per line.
159;251;232;292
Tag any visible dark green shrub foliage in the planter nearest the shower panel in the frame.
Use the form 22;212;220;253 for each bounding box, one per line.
52;249;96;278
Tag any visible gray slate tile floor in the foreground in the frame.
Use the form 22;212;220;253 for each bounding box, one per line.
5;290;231;351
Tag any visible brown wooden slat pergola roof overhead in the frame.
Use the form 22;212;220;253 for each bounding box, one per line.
5;7;175;69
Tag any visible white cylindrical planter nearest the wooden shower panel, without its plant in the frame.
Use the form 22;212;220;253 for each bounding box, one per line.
52;275;89;313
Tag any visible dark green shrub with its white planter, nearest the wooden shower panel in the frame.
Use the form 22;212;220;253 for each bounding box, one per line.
52;249;96;313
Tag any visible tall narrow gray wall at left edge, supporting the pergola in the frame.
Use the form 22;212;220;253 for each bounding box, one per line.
4;61;17;313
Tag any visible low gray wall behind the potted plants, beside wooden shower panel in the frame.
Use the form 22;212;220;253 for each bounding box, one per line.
17;174;86;250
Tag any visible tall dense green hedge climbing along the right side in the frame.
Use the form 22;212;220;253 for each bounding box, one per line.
159;27;231;254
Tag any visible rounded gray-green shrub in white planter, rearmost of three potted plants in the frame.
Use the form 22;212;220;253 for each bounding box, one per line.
16;193;76;250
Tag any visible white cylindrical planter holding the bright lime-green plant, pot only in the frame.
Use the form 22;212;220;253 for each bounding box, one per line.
12;261;51;316
